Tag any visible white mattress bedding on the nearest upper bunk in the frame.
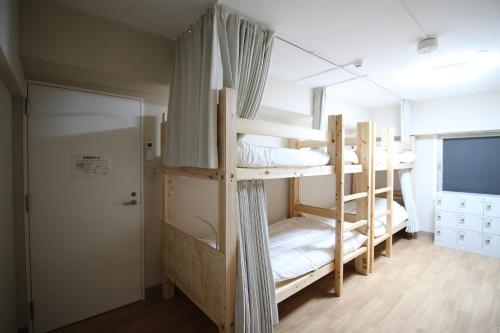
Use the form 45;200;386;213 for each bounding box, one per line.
238;142;358;168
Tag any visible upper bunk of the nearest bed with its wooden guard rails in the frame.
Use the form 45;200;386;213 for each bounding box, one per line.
162;88;363;181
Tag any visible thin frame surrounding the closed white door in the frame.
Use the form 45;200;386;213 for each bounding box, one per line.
23;80;146;333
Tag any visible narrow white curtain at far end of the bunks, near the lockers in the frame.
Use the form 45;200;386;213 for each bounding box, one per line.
399;100;420;233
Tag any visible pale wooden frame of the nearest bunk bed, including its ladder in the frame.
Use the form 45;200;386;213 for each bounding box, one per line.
162;88;375;332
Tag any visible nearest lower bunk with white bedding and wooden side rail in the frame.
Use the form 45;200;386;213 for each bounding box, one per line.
200;214;368;303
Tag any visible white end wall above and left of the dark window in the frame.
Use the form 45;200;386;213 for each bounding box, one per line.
410;91;500;232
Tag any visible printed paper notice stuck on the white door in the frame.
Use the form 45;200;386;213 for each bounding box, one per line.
71;154;111;179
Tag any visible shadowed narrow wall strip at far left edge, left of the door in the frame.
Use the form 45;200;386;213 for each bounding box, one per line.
0;79;18;332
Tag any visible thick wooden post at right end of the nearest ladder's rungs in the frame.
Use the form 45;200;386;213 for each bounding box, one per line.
353;122;375;275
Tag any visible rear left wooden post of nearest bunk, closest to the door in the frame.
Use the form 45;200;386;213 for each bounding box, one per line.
160;113;175;299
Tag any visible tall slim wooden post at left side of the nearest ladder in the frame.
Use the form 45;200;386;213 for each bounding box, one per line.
328;115;345;296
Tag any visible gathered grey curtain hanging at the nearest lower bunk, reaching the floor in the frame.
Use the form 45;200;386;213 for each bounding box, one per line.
235;180;278;333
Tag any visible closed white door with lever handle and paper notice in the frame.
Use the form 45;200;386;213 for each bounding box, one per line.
28;84;142;332
